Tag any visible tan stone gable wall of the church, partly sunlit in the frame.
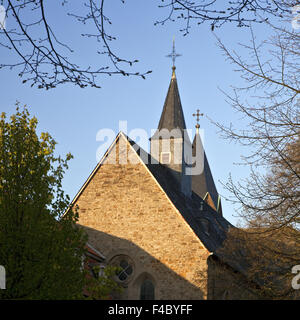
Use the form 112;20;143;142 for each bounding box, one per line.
75;135;209;299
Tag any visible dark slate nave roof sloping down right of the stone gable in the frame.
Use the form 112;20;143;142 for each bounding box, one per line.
127;133;260;276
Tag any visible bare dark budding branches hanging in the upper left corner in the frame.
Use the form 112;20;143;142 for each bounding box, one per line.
0;0;151;89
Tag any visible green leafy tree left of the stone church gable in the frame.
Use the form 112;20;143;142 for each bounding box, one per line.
0;106;86;299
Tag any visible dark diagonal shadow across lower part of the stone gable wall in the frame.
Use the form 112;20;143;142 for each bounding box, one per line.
79;225;206;300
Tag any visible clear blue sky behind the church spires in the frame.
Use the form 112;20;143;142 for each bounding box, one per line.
0;1;286;224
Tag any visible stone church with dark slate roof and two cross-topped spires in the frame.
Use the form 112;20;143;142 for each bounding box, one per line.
72;53;258;300
